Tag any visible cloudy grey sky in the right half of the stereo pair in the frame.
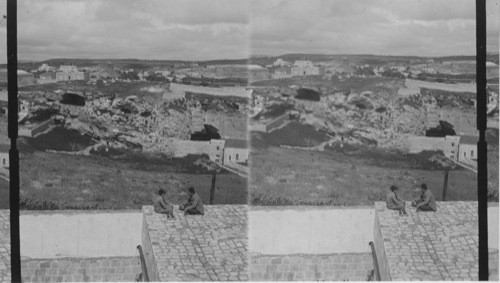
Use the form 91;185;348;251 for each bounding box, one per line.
254;0;500;56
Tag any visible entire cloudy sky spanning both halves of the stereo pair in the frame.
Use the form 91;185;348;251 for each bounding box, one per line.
0;0;500;63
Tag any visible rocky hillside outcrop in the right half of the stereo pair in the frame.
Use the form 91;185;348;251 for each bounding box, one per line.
264;81;474;150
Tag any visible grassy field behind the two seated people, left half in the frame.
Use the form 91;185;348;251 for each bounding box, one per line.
20;152;247;209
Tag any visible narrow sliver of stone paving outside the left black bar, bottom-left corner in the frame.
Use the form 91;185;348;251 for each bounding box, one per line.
0;210;11;282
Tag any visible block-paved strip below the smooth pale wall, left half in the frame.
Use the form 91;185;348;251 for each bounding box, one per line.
19;256;142;282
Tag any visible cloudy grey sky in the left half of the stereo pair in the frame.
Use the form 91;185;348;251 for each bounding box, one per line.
0;0;249;60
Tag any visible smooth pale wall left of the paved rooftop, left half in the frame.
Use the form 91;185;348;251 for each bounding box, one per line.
19;210;142;259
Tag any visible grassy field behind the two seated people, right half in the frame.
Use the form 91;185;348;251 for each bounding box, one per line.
249;147;477;206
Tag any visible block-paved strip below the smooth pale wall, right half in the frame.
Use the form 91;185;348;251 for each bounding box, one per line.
250;253;373;281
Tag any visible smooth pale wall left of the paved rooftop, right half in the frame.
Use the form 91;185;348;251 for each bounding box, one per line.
248;206;375;255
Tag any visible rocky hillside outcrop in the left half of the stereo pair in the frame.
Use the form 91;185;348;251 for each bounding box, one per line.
22;90;248;152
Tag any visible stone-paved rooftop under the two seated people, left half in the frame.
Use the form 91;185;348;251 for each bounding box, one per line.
142;205;248;281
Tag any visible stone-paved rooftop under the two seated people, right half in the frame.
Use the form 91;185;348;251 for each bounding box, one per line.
375;202;498;281
